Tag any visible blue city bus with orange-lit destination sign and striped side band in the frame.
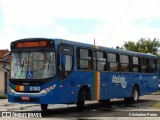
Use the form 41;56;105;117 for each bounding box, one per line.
4;38;158;110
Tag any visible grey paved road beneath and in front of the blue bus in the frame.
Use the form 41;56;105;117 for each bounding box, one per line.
0;95;160;120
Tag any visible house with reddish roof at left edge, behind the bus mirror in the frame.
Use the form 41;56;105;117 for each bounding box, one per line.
0;49;10;94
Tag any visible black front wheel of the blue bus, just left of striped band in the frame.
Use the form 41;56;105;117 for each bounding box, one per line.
76;89;85;111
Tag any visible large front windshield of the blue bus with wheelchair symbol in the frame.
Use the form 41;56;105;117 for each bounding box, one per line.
10;51;56;79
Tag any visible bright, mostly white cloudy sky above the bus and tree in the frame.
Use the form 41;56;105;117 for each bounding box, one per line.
0;0;160;49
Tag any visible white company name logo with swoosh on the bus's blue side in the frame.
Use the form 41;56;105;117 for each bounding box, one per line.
112;75;127;88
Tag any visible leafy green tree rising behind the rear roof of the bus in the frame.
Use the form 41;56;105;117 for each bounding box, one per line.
123;38;160;55
